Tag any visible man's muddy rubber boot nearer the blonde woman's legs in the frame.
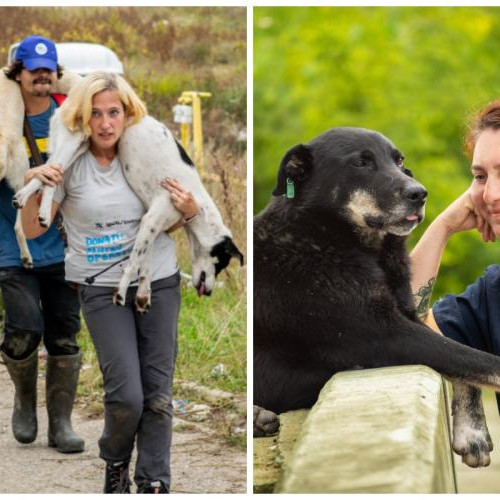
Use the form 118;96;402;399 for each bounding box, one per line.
46;353;85;453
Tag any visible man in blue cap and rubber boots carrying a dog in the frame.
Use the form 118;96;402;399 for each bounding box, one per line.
0;35;84;453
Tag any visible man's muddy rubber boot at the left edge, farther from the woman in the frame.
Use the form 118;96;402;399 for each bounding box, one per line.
0;349;38;444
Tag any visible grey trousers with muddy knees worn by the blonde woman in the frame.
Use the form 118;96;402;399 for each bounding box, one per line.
78;273;180;488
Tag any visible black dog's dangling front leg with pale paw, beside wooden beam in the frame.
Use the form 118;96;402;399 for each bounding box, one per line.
452;382;493;467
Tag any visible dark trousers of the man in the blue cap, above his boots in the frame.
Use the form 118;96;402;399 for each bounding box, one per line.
0;262;80;359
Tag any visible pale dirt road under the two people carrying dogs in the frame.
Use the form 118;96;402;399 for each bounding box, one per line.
0;364;246;493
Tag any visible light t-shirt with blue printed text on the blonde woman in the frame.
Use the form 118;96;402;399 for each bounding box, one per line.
54;151;178;287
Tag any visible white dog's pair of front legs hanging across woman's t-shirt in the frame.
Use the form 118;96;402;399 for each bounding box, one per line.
113;192;181;313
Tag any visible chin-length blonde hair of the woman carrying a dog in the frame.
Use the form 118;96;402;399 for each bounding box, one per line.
60;71;147;137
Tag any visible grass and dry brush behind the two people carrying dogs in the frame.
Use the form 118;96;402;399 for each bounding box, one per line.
0;7;247;413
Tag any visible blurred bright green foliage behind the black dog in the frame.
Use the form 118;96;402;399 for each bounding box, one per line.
254;7;500;298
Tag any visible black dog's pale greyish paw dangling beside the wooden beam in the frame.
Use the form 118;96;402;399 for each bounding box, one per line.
453;427;493;468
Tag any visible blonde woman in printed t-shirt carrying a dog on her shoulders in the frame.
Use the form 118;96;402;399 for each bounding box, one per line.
22;73;198;493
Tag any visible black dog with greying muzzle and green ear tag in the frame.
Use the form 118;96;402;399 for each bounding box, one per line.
254;128;500;466
